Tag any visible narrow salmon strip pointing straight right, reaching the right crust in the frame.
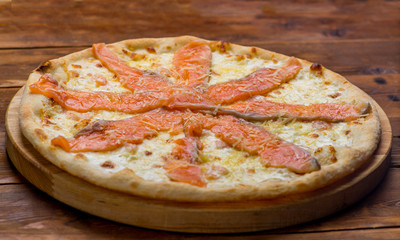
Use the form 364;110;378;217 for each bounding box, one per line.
229;100;363;122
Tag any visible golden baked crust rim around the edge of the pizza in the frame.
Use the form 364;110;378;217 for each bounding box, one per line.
20;36;381;202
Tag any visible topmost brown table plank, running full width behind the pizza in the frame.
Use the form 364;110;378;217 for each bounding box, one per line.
0;0;400;48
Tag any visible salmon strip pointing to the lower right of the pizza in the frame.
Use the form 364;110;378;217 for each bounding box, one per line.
205;116;320;174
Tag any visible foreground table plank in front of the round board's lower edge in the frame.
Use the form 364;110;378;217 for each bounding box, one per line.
0;168;400;239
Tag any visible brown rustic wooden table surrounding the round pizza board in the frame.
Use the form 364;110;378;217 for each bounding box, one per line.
0;0;400;239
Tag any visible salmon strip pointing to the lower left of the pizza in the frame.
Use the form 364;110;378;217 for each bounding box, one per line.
51;110;182;152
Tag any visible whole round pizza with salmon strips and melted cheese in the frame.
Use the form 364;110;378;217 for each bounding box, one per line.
19;36;381;202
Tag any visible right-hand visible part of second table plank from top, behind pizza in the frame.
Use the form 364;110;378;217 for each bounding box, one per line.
260;39;400;75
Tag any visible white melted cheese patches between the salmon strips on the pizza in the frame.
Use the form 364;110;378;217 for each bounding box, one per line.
39;45;360;187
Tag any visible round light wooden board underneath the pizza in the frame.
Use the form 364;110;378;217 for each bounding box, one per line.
6;89;392;233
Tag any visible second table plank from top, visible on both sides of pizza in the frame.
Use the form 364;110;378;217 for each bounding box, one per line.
0;39;400;81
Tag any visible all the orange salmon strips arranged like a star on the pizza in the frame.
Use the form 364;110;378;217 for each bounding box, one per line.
29;41;363;187
